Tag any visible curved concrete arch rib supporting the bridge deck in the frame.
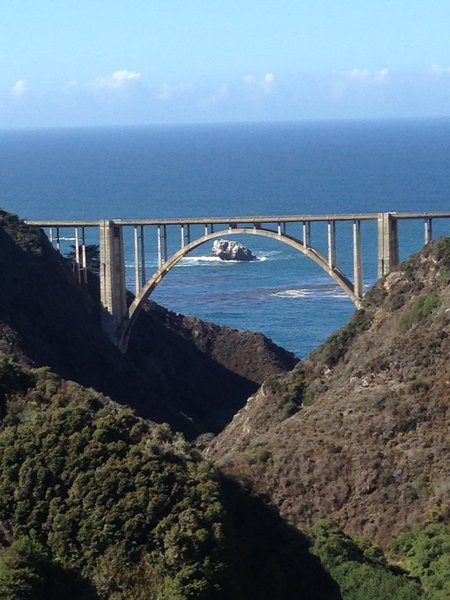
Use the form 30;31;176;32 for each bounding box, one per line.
119;227;361;352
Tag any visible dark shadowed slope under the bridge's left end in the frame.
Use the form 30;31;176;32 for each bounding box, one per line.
0;211;295;436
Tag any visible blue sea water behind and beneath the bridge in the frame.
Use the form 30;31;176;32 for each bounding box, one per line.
0;119;450;357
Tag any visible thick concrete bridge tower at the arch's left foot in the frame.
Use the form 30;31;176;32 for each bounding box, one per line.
100;221;127;345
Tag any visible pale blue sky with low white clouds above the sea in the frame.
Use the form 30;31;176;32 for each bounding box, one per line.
0;0;450;128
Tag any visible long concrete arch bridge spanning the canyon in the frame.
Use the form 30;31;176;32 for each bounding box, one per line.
26;212;450;352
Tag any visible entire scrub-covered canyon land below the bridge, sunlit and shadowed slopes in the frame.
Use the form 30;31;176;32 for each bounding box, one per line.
0;212;450;600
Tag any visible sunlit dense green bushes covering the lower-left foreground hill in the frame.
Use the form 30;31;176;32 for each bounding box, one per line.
0;363;223;598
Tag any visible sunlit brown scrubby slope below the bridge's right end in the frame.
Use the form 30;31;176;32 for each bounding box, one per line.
207;238;450;546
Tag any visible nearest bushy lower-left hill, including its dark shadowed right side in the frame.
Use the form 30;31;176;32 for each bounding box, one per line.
0;356;338;600
